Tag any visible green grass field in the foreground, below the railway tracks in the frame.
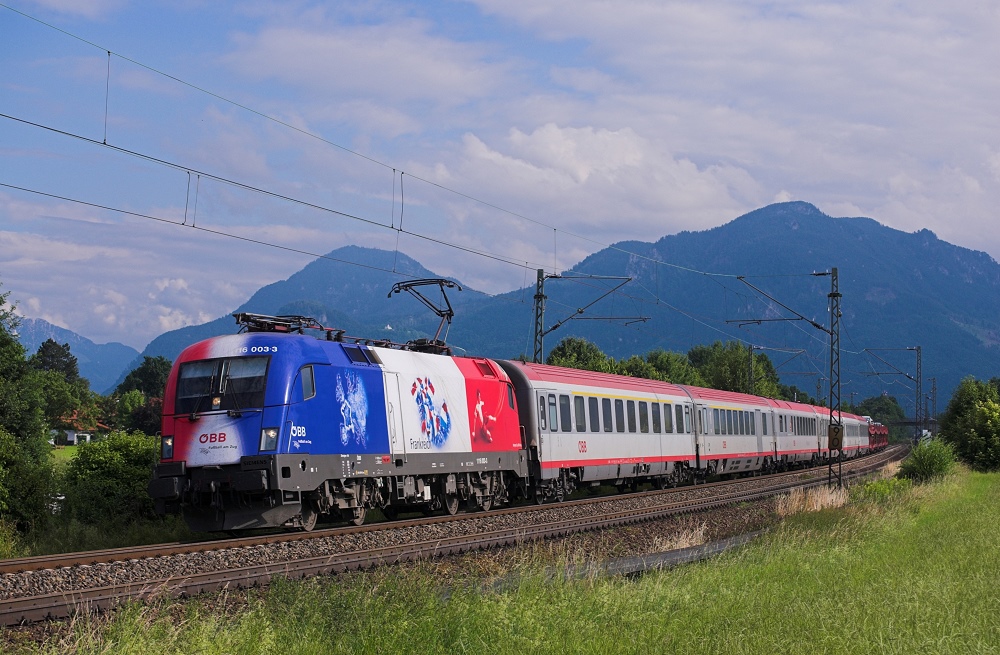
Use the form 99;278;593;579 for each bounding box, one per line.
7;472;1000;654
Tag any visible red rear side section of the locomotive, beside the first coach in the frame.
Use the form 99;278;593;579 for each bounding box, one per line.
455;357;523;452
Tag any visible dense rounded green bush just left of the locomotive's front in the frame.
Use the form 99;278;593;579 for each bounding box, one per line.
63;432;157;526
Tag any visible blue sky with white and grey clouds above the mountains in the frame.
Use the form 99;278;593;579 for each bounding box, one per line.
0;0;1000;350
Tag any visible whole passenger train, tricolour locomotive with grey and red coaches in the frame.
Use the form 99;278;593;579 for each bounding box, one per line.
148;313;886;531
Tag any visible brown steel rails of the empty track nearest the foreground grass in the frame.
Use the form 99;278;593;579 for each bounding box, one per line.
0;451;901;625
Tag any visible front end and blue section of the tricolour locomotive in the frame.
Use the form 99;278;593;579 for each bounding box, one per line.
149;333;389;531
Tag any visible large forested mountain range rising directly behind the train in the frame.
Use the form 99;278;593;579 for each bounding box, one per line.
135;202;1000;412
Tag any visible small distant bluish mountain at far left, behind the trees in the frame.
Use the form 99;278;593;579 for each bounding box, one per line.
17;318;139;393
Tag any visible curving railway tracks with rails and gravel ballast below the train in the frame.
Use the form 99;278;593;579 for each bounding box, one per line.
0;448;905;625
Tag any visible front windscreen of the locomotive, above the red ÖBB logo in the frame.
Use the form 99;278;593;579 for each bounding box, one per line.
175;357;270;414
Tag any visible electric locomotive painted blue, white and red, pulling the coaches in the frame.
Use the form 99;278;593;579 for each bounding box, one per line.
149;314;528;531
